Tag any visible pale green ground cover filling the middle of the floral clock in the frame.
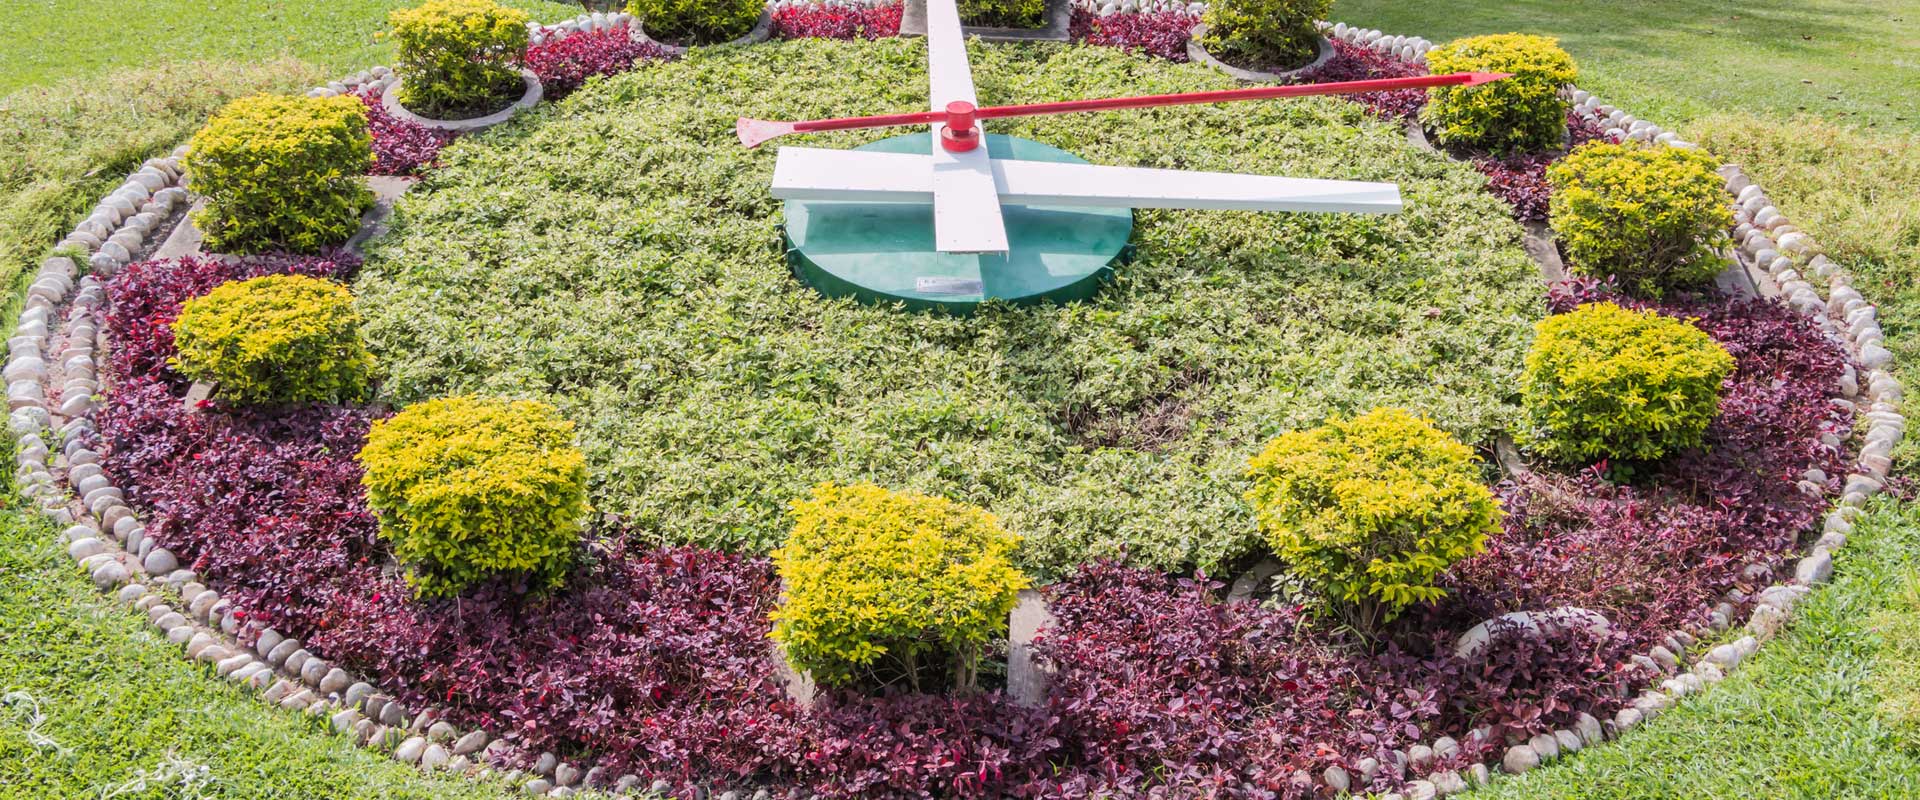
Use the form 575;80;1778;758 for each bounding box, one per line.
355;40;1544;576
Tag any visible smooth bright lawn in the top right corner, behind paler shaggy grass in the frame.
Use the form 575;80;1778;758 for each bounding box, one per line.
1331;0;1920;132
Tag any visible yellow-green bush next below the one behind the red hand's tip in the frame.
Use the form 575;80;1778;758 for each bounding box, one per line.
1548;142;1734;297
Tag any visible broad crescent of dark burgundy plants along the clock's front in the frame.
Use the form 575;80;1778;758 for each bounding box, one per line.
100;199;1849;798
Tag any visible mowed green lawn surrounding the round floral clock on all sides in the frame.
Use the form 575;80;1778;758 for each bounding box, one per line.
0;0;1920;800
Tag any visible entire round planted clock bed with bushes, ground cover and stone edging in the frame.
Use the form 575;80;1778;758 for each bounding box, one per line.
8;0;1905;798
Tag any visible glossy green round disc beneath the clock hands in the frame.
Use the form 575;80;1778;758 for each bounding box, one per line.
785;132;1133;315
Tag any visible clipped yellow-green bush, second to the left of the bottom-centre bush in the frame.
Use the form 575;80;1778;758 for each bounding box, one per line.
171;274;372;403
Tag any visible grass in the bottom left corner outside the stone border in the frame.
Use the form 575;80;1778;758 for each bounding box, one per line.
0;506;526;800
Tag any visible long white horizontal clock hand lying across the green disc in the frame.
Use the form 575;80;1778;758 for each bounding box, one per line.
774;148;1402;213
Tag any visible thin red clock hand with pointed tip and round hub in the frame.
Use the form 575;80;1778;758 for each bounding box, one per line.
733;73;1511;150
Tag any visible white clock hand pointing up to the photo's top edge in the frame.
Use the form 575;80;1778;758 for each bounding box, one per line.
927;0;1006;253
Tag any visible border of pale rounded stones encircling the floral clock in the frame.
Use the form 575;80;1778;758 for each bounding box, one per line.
4;12;1907;800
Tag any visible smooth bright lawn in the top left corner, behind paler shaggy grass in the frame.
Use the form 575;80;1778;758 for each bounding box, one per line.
0;0;582;94
